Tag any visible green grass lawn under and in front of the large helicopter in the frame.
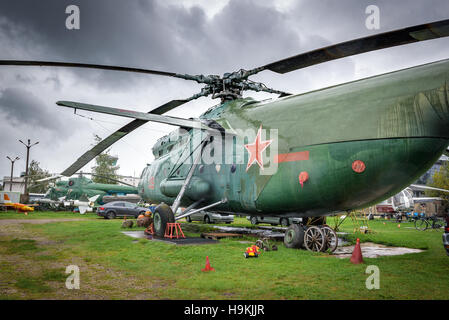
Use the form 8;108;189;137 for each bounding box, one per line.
0;212;449;300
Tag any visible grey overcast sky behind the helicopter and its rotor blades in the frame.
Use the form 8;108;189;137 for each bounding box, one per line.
0;0;449;179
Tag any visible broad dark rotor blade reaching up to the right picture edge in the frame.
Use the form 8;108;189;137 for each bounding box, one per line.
260;20;449;74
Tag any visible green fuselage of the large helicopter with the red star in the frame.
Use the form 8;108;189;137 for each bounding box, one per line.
138;60;449;217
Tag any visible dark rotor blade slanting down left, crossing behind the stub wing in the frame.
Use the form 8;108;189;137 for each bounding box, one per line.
61;99;190;177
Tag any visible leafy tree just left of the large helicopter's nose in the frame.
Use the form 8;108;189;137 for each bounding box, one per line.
92;135;120;184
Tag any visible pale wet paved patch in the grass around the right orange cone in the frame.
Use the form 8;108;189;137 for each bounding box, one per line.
333;242;424;258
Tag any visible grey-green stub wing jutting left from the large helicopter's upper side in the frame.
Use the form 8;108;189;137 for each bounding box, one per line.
56;101;203;128
